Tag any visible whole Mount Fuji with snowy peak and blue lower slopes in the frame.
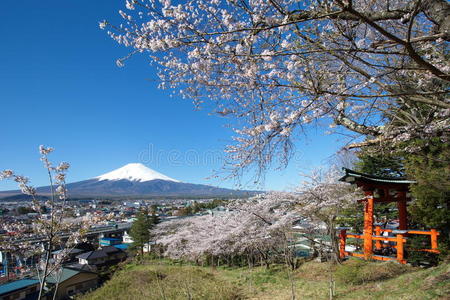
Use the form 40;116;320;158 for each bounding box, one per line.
0;163;255;200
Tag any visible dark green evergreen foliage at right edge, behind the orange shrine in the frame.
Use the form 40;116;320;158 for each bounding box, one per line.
405;138;450;265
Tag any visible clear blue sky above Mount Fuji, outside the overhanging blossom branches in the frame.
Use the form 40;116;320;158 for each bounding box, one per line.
0;0;339;190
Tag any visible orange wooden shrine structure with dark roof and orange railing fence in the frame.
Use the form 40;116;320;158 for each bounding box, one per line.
339;168;439;264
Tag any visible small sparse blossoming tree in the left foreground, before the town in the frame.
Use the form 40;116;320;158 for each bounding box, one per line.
0;145;90;299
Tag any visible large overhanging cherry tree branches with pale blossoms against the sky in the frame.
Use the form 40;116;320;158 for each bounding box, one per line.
100;0;450;174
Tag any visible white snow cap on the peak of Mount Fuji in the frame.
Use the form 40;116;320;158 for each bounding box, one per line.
95;163;179;182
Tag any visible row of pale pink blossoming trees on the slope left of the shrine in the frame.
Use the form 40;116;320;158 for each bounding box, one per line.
154;168;358;268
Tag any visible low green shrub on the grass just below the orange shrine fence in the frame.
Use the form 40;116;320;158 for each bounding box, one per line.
335;259;411;285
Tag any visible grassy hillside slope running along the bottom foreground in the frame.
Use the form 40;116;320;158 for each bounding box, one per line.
81;259;450;300
